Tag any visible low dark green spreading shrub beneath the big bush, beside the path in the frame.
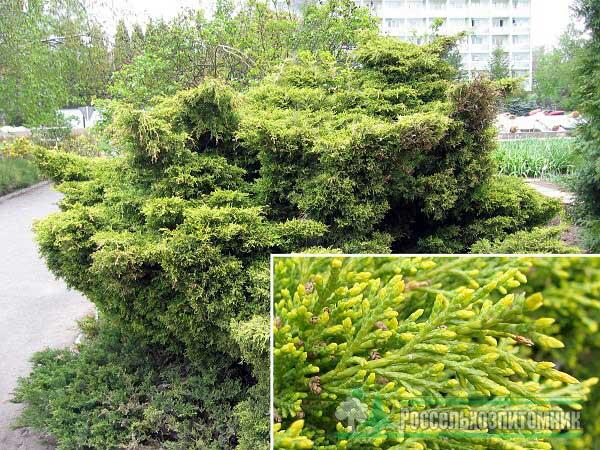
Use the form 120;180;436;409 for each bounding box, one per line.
15;321;248;450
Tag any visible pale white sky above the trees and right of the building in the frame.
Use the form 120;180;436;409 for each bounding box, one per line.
92;0;574;47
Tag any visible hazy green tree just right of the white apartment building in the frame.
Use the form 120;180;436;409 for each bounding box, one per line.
534;24;585;109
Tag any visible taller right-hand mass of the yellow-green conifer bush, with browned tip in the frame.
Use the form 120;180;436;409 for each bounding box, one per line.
238;38;558;252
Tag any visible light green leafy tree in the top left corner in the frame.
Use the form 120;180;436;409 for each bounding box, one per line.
0;0;110;125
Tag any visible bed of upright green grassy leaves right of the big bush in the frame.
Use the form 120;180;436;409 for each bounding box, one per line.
493;138;580;178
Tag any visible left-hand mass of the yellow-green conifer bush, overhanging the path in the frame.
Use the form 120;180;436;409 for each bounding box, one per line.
35;82;326;449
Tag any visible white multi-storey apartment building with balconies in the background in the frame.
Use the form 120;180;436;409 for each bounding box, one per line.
357;0;532;89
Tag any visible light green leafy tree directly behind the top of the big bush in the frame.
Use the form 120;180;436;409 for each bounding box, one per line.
105;0;376;104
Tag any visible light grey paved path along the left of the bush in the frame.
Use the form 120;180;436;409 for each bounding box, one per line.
0;185;93;450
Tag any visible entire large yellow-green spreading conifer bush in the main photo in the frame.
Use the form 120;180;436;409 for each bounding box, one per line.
23;38;555;449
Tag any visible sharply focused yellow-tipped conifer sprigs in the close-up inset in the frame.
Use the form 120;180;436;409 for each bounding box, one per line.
273;257;597;450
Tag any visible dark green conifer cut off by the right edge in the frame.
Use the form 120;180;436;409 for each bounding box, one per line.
576;0;600;251
